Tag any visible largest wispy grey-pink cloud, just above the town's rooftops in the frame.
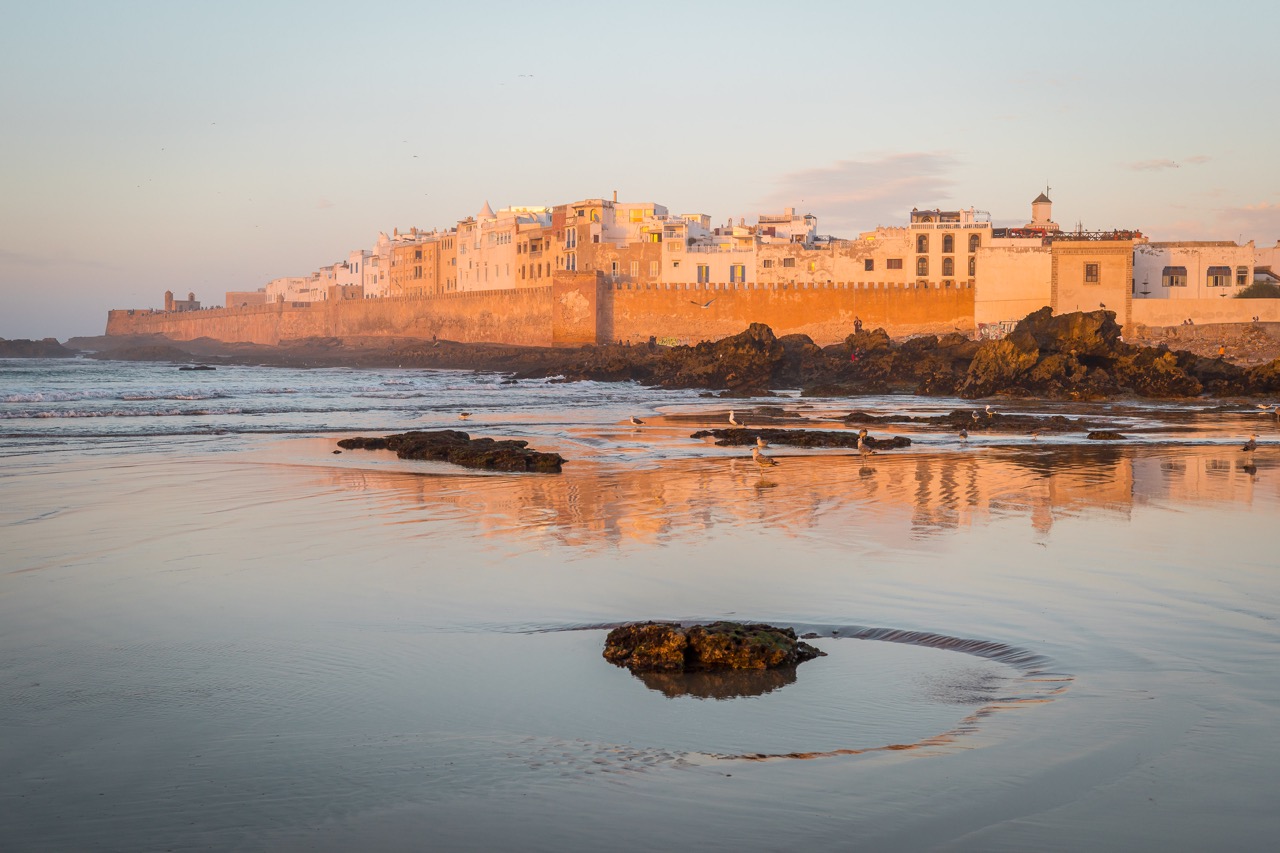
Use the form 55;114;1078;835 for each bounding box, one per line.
762;151;957;236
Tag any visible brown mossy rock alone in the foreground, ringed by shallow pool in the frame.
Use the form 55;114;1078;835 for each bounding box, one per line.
604;622;826;672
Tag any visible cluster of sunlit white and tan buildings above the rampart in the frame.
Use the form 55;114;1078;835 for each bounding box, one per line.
212;192;1280;327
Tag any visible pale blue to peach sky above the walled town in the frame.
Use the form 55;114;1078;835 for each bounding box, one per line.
0;0;1280;339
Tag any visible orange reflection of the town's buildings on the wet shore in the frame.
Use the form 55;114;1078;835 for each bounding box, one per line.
322;444;1280;547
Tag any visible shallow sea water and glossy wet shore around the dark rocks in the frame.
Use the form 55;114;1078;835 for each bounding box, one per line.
0;359;1280;852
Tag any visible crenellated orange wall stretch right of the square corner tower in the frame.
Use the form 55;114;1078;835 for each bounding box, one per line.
600;282;974;346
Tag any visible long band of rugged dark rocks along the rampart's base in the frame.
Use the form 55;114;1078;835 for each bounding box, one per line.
55;309;1280;401
